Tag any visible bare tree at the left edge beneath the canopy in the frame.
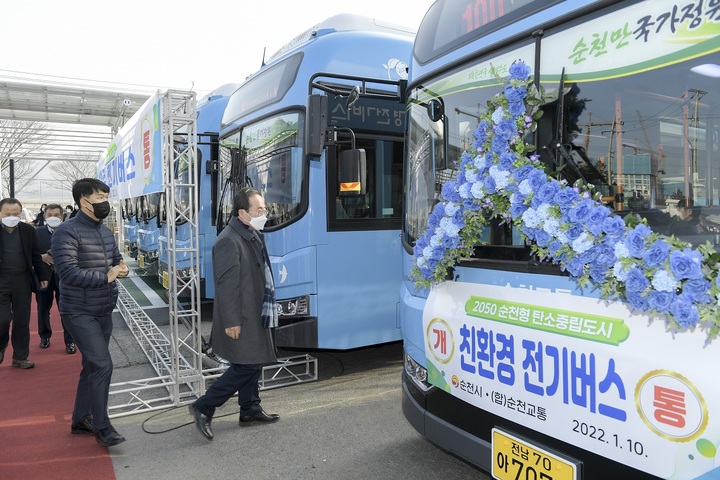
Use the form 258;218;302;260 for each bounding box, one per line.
0;119;50;195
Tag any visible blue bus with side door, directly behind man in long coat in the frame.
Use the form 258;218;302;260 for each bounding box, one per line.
218;15;413;349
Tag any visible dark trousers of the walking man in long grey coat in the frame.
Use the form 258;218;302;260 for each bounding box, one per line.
195;363;262;418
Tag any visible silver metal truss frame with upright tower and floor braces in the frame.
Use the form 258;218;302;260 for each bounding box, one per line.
109;90;318;417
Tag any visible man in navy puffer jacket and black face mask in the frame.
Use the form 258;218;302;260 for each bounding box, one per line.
51;178;129;447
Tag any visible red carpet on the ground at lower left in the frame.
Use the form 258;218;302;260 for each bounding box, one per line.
0;302;115;480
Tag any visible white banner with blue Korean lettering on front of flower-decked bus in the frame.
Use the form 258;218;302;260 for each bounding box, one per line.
423;282;720;480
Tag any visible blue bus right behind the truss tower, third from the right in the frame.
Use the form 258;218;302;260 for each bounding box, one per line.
157;83;238;299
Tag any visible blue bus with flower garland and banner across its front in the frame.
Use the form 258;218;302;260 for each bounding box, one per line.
400;0;720;480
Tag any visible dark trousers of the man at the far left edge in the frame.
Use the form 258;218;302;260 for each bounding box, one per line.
0;272;32;360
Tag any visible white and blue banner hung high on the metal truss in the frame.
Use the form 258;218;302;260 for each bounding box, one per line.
97;93;163;200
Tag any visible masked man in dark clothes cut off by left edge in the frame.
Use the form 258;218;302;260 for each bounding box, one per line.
0;198;50;369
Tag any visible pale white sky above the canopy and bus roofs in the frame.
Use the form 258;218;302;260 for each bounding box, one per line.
0;0;433;96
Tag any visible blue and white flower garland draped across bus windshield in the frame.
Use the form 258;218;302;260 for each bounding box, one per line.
412;61;720;340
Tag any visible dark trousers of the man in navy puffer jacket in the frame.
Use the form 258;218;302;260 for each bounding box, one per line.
63;314;113;430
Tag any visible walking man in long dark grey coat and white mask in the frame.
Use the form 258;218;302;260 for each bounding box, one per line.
190;188;280;440
